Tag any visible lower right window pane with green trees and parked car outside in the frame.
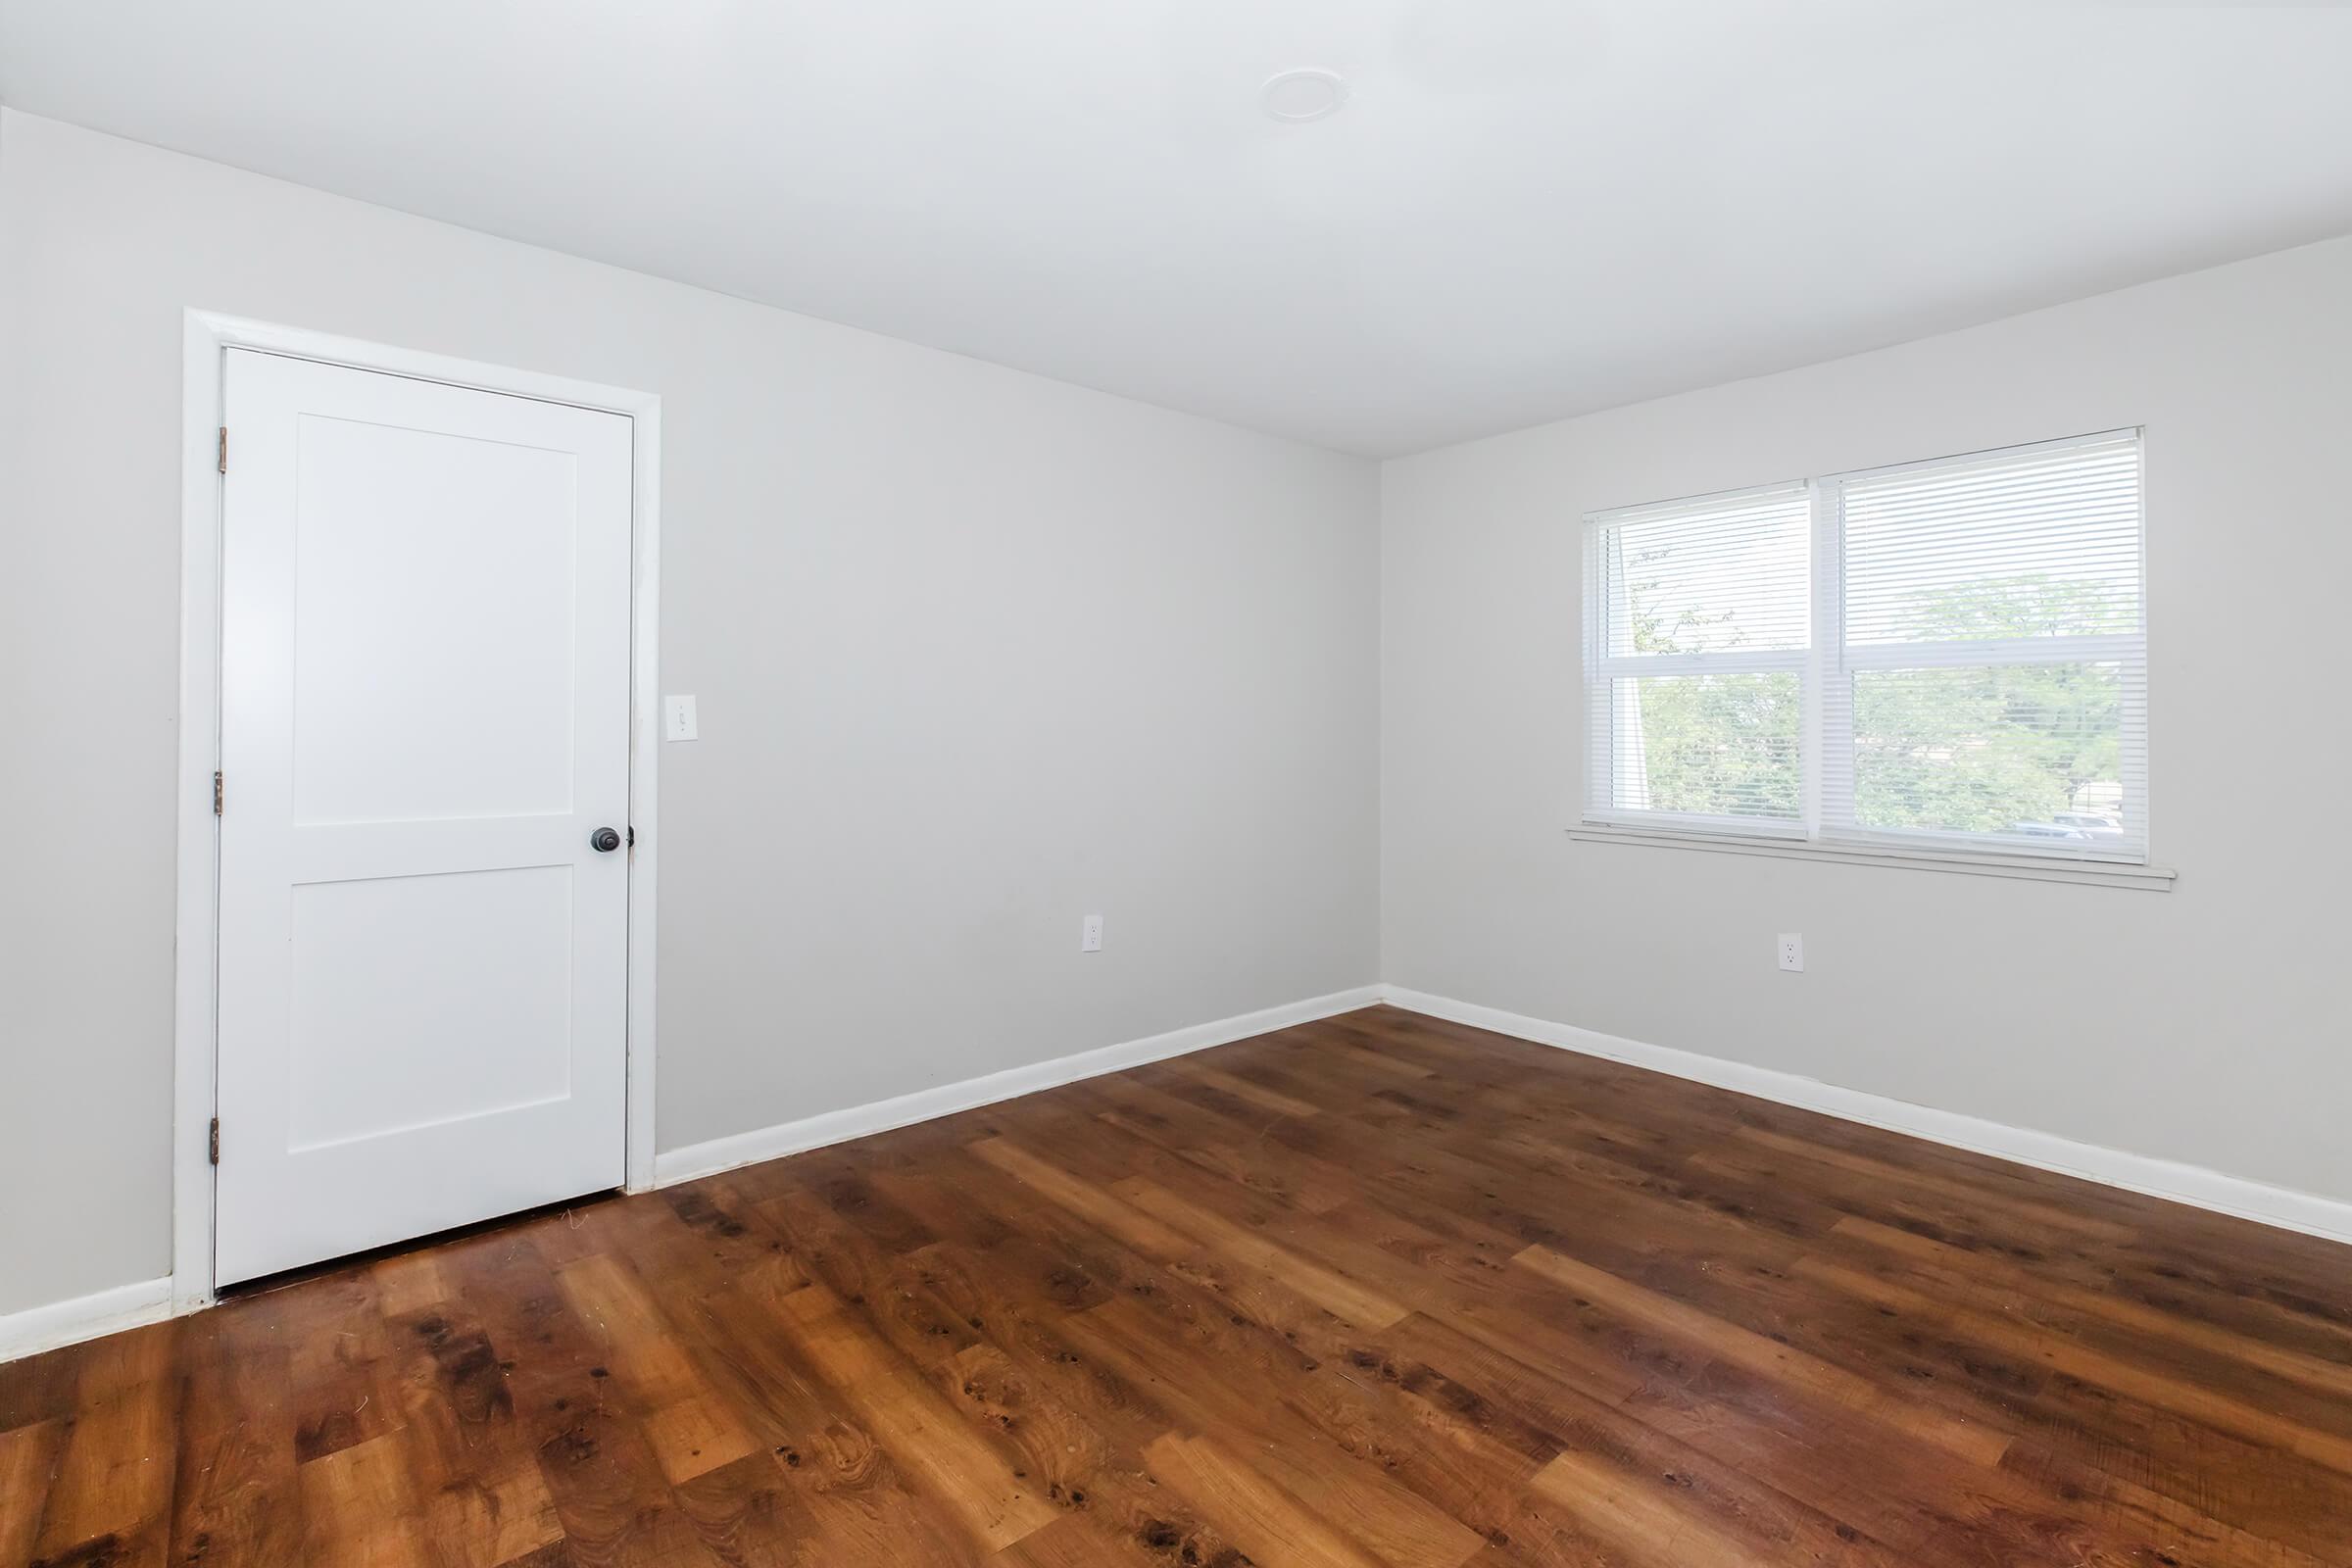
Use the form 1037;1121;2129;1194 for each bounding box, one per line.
1853;662;2138;854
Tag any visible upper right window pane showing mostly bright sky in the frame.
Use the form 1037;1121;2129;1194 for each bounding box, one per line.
1841;435;2140;644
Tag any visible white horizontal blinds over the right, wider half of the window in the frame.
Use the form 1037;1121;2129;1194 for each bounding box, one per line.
1823;430;2147;860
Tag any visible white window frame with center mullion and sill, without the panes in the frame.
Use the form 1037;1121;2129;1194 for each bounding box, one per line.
1569;425;2174;886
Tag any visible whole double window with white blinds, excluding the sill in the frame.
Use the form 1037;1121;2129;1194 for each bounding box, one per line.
1586;430;2147;862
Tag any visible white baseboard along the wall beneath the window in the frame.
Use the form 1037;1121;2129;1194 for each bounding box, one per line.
1381;985;2352;1244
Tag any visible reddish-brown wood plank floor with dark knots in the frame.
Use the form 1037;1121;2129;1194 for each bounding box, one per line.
14;1008;2352;1568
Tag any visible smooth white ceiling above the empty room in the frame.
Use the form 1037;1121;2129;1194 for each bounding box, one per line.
0;0;2352;454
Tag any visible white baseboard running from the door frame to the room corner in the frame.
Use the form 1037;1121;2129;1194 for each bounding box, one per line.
654;985;1381;1187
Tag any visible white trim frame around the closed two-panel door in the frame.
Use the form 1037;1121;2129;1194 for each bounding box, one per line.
172;311;661;1312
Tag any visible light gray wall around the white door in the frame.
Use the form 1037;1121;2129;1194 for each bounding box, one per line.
0;113;1378;1312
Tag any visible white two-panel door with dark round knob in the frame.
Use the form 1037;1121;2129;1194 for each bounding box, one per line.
214;350;630;1284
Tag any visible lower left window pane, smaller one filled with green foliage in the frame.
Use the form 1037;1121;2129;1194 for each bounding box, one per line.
1609;672;1804;823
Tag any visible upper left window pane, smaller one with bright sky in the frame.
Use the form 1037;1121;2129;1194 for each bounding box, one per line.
1599;487;1811;659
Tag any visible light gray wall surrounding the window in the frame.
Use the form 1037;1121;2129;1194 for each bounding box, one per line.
1381;240;2352;1199
